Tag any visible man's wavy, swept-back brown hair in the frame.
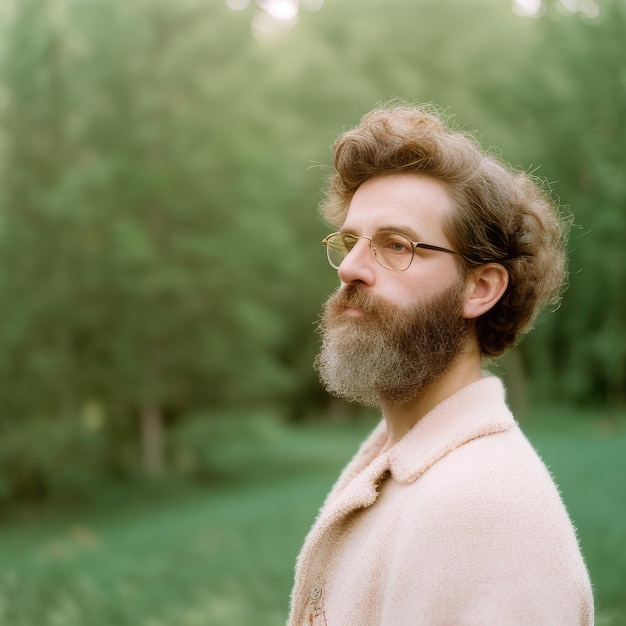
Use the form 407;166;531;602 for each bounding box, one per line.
321;105;569;357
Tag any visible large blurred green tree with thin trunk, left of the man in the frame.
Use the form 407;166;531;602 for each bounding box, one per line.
1;0;310;473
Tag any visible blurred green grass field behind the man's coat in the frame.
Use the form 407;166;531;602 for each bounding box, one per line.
0;408;626;626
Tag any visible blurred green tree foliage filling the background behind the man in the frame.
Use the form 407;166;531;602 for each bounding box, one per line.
0;0;626;500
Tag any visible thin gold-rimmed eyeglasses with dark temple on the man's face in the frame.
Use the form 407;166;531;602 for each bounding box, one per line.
322;231;465;272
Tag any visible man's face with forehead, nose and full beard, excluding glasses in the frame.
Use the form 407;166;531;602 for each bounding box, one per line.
316;174;470;405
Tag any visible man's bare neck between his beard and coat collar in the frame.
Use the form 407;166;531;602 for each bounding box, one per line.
380;350;483;454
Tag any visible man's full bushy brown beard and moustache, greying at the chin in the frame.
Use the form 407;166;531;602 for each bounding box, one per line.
315;282;471;406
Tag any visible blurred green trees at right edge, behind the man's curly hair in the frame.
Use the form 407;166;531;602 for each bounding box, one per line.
472;2;626;407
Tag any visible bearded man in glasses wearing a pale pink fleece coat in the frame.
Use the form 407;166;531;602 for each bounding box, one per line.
289;106;593;626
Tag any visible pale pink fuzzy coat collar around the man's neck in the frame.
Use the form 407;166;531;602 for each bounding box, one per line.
322;376;515;517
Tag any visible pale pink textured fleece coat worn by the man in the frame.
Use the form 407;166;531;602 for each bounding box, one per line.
288;377;593;626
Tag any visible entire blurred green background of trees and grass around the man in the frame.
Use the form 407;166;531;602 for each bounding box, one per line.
0;0;626;626
